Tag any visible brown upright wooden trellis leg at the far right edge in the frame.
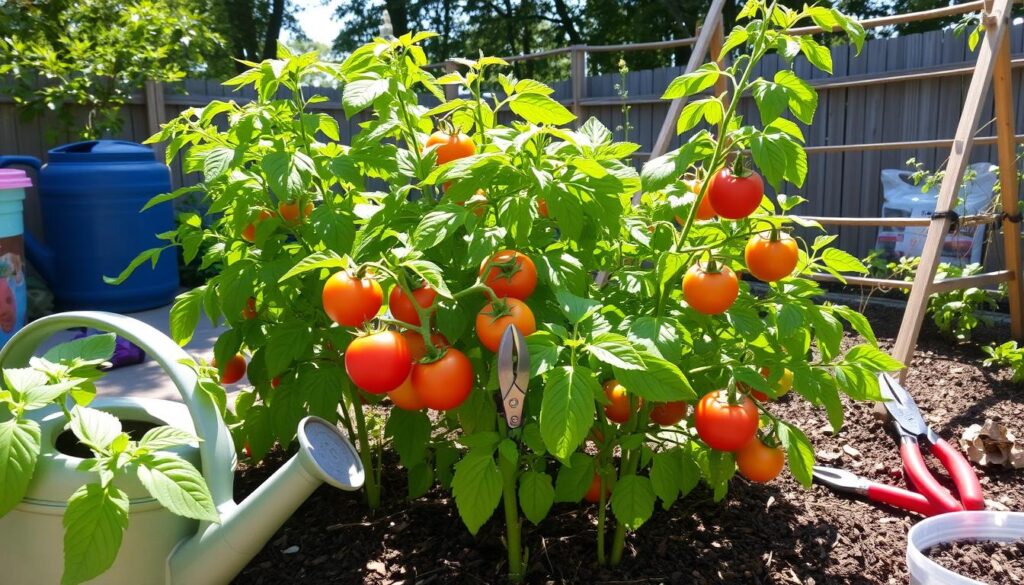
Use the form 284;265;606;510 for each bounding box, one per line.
992;22;1024;339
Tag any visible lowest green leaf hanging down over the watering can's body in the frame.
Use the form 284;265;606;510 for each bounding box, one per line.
60;484;128;585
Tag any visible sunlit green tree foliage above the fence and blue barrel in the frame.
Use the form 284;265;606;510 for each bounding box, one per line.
0;0;223;141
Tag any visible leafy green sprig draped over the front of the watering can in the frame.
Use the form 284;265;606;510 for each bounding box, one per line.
0;333;219;585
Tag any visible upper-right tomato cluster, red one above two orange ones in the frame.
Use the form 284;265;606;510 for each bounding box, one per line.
677;168;800;315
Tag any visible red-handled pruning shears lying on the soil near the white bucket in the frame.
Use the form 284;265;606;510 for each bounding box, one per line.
813;374;985;515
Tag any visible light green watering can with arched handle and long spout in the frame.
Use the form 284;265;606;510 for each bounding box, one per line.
0;311;364;585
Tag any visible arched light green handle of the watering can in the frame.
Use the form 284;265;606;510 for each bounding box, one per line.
0;310;234;508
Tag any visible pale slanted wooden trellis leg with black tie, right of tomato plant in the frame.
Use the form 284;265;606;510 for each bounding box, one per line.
893;0;1013;377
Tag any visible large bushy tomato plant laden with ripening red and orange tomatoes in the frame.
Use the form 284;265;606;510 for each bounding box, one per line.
121;5;901;580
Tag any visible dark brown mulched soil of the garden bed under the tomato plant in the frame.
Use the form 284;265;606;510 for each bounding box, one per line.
236;308;1024;585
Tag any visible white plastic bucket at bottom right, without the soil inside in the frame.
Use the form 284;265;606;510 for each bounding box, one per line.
906;511;1024;585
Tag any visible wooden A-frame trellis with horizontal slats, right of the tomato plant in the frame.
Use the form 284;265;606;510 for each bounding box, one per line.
651;0;1024;379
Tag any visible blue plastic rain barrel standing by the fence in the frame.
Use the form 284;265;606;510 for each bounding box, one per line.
0;140;178;312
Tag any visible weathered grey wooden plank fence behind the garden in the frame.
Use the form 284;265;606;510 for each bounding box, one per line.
0;19;1024;266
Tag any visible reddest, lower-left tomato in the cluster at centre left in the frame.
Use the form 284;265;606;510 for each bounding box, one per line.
345;331;413;394
